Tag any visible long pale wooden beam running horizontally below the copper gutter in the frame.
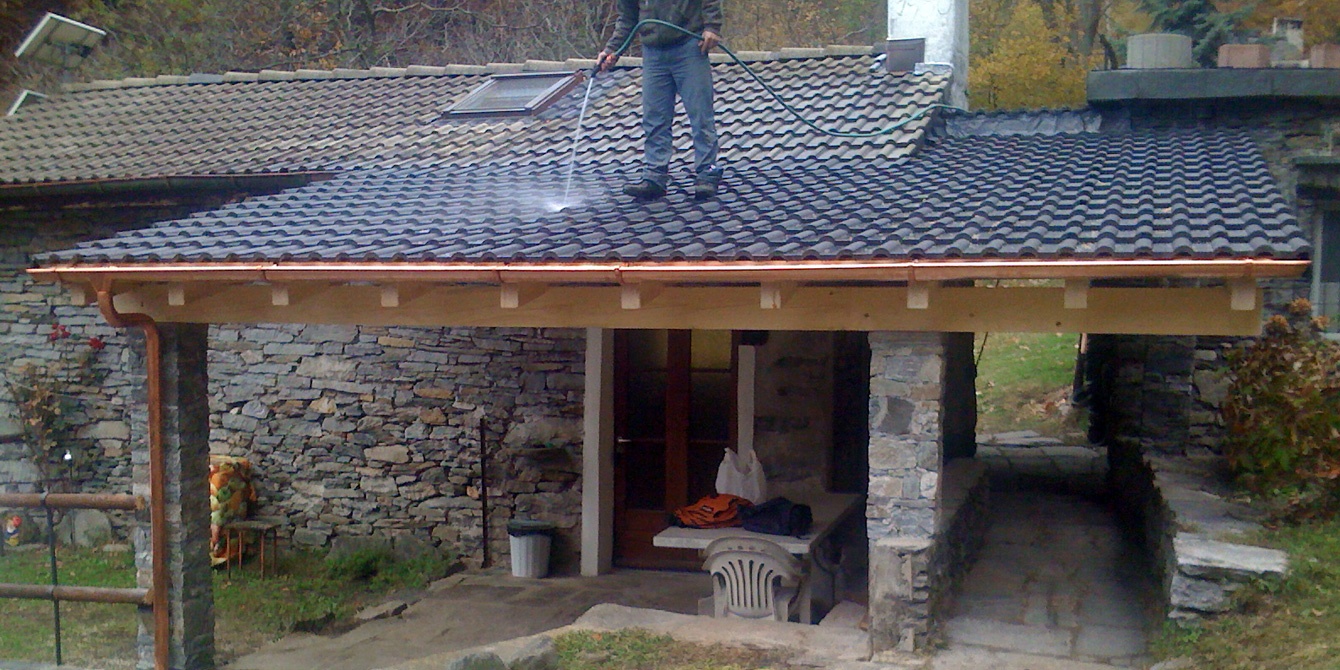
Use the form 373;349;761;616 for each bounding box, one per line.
117;283;1261;335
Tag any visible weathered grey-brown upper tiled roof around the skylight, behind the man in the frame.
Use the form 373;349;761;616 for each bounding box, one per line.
0;47;946;189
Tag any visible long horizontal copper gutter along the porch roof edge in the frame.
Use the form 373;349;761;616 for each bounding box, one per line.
28;259;1311;284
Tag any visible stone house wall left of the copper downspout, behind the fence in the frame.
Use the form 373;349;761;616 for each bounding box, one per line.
0;194;233;536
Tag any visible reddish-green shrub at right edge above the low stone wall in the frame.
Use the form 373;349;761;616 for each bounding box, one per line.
1223;299;1340;516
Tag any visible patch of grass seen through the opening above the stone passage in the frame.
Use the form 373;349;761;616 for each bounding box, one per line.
977;332;1084;440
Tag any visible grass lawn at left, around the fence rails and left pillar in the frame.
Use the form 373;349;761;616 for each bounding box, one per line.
0;547;448;669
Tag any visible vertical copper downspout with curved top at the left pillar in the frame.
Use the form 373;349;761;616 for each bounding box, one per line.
94;281;172;670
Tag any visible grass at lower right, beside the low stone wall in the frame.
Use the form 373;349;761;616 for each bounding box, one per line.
1154;520;1340;670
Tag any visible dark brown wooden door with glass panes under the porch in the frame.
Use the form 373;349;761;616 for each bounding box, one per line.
614;330;736;570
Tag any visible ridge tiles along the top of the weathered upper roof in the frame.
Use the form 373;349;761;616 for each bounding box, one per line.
60;44;880;92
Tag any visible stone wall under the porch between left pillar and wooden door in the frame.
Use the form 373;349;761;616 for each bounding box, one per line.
210;326;586;568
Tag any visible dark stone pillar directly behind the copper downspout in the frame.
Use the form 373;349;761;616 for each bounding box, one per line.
131;324;214;670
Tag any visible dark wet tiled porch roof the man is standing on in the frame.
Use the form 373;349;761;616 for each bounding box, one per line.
46;127;1309;263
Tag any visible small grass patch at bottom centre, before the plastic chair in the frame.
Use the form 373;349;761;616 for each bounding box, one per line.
553;628;787;670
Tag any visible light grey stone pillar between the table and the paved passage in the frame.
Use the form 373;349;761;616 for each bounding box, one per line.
866;332;946;651
